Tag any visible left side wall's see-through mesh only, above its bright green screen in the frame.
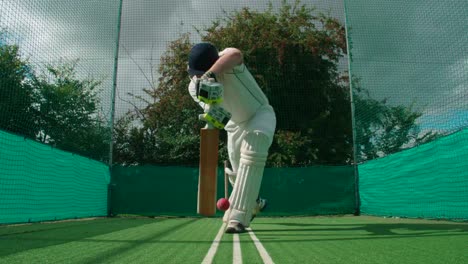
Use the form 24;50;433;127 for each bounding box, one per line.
0;0;120;162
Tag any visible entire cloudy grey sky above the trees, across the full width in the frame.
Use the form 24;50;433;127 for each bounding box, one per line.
0;0;468;130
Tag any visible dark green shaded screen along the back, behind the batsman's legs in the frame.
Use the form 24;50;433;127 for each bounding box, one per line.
111;166;355;216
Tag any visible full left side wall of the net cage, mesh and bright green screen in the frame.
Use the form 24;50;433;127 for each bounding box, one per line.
0;0;120;223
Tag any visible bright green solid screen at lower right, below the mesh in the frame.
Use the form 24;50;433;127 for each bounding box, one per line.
359;130;468;220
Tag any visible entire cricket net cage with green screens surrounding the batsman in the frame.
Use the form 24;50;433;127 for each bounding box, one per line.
0;0;468;224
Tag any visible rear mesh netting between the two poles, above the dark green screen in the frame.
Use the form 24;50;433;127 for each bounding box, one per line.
109;0;352;167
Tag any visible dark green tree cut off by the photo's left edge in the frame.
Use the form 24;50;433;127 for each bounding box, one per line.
0;32;36;138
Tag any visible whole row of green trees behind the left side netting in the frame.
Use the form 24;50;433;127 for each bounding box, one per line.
0;31;111;161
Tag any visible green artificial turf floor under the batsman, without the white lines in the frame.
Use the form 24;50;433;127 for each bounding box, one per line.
0;216;468;264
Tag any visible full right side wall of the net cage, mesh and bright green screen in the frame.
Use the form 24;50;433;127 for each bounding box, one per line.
345;0;468;219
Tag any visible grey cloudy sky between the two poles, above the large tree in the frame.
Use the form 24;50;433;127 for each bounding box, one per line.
113;0;344;115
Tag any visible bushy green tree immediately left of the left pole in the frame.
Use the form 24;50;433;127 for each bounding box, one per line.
34;61;110;161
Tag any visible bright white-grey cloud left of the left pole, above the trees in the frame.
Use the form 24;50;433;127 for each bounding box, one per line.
0;0;122;116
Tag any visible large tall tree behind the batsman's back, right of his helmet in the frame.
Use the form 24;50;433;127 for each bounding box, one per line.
199;1;352;166
